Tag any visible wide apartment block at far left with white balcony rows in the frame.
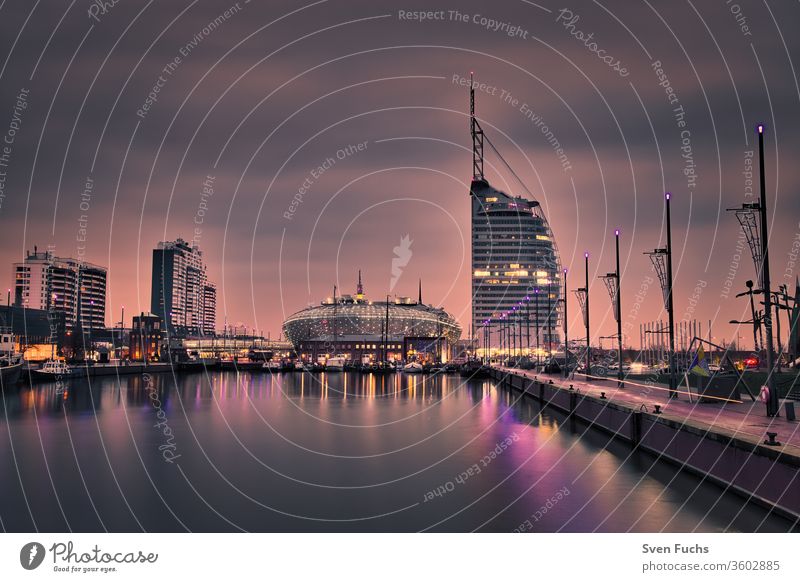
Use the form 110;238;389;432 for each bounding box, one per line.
14;248;106;332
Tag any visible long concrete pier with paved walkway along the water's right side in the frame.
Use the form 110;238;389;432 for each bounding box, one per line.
492;367;800;520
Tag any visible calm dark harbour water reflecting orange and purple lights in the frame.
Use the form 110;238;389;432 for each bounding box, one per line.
0;372;791;532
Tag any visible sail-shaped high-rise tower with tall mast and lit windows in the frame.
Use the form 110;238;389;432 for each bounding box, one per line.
470;83;563;349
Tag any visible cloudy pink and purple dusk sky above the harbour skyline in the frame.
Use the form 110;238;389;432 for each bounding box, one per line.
0;0;800;345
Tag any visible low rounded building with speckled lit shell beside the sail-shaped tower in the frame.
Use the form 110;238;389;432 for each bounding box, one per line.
283;274;461;361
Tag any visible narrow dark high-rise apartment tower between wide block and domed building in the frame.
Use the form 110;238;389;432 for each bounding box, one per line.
150;238;217;336
